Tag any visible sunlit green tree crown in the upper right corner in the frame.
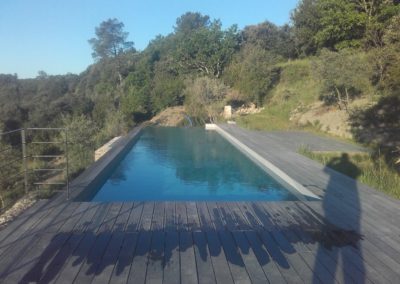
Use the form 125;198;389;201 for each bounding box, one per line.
291;0;400;55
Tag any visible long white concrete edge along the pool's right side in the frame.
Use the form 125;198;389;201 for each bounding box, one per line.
206;124;320;200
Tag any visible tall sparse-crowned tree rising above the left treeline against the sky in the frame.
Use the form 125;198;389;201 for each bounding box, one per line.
89;18;134;83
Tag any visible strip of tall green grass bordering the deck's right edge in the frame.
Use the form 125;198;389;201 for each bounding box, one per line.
298;147;400;199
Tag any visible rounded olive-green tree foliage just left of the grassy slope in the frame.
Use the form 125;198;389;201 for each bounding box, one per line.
224;45;280;105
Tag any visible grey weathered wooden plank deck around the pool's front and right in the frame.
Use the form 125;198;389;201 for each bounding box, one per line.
0;126;400;283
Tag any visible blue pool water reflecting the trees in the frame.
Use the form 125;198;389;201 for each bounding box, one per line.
86;127;297;201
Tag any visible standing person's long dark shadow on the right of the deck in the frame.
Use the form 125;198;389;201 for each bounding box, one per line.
313;153;365;283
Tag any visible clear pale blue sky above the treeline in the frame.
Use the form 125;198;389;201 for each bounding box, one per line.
0;0;298;78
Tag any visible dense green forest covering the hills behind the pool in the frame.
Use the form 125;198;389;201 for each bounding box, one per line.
0;0;400;207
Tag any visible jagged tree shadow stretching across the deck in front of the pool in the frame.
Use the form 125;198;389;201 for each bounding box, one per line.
1;193;368;283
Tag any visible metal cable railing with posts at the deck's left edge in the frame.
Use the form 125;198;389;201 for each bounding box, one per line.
0;128;70;211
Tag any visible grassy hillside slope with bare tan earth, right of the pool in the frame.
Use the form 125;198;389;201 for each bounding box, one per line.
238;58;377;139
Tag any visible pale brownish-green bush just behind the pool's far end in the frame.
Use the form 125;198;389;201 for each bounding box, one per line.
185;77;228;123
